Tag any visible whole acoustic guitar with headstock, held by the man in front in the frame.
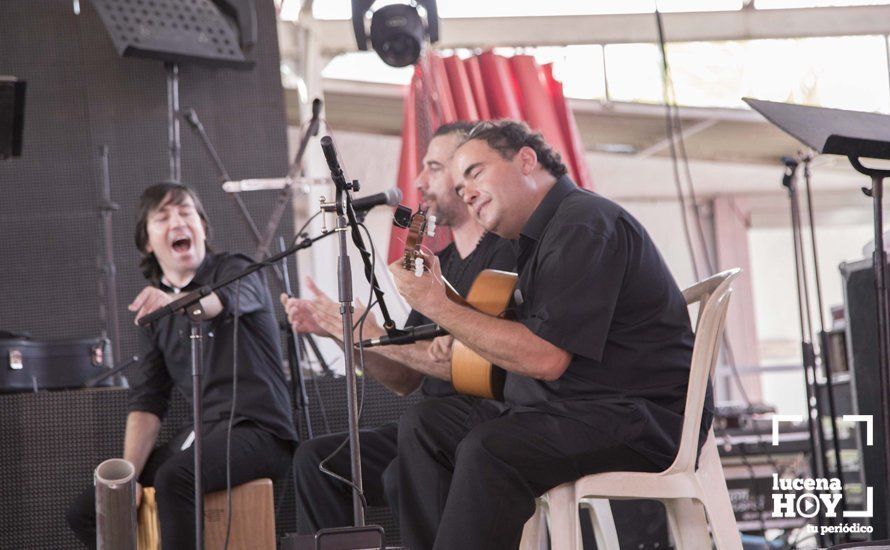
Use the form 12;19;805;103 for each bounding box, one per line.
402;210;518;401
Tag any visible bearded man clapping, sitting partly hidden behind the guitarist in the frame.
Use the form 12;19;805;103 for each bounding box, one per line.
282;122;515;532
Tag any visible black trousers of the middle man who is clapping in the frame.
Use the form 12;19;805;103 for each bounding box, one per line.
294;422;398;534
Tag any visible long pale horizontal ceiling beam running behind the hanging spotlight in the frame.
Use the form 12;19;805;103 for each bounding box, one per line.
296;6;890;54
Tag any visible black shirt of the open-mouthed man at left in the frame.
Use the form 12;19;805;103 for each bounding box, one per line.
129;252;297;441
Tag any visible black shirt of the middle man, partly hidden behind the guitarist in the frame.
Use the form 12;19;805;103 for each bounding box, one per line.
405;233;516;397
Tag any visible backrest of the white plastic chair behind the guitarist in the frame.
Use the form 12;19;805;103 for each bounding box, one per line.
666;268;742;473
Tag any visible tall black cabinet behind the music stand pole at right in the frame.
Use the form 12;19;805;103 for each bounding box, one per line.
840;259;887;539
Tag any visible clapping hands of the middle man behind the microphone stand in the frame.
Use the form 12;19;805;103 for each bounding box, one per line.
280;277;386;340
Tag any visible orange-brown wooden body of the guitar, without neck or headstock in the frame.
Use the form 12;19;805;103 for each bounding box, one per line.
449;269;518;401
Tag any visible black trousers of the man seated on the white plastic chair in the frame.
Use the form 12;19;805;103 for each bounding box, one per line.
398;396;658;550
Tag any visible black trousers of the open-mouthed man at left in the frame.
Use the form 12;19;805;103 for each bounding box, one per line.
66;422;293;550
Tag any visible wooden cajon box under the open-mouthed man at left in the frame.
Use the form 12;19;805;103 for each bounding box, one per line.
137;478;275;550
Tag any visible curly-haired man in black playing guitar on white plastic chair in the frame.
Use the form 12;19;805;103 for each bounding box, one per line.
390;121;710;550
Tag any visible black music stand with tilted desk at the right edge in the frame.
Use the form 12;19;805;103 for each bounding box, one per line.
742;98;890;536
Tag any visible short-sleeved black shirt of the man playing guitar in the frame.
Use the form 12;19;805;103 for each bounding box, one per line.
504;176;712;467
